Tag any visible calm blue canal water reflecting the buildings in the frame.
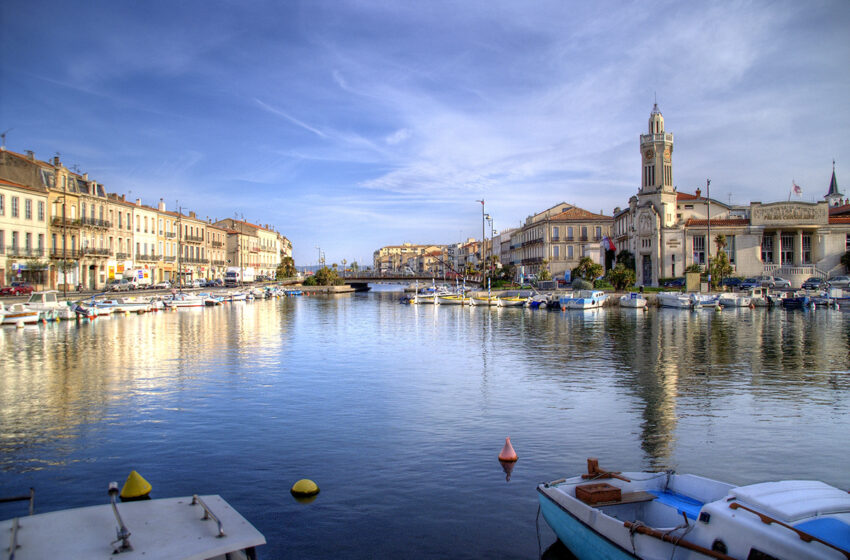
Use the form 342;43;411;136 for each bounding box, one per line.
0;287;850;558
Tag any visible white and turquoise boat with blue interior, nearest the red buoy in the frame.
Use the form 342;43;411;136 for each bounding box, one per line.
537;459;850;560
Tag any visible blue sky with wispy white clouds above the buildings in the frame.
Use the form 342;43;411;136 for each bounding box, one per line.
0;0;850;265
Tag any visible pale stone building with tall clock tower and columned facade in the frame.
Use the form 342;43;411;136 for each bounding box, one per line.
613;105;850;287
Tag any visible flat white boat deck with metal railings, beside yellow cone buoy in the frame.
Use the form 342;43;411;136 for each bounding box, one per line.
0;483;266;560
